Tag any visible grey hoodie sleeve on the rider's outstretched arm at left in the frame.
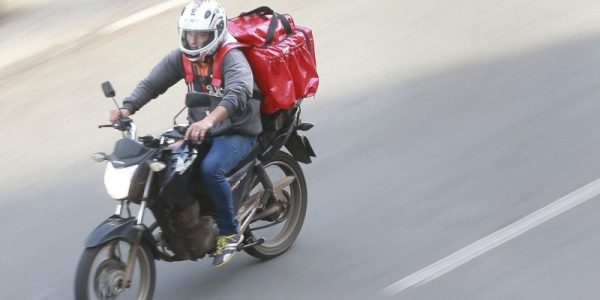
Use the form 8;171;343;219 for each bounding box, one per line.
123;49;184;113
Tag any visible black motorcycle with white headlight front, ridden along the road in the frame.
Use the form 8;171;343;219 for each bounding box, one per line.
75;82;316;300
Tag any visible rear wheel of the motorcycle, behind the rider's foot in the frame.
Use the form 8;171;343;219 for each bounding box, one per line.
244;151;307;260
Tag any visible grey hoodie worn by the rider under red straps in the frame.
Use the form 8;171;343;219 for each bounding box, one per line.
123;49;262;135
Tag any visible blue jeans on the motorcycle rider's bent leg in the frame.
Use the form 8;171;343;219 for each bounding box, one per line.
200;135;256;235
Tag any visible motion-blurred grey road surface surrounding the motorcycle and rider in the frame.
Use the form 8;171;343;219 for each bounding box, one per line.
0;0;600;300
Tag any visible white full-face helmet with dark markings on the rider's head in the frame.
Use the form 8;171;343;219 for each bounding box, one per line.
179;0;227;61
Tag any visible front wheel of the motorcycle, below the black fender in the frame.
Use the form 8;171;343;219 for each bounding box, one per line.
75;239;156;300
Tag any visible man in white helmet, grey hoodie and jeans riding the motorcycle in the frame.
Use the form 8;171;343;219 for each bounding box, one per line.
110;0;262;266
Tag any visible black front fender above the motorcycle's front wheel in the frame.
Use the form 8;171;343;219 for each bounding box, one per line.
85;215;154;250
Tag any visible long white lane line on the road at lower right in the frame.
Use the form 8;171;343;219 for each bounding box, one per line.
381;178;600;296
